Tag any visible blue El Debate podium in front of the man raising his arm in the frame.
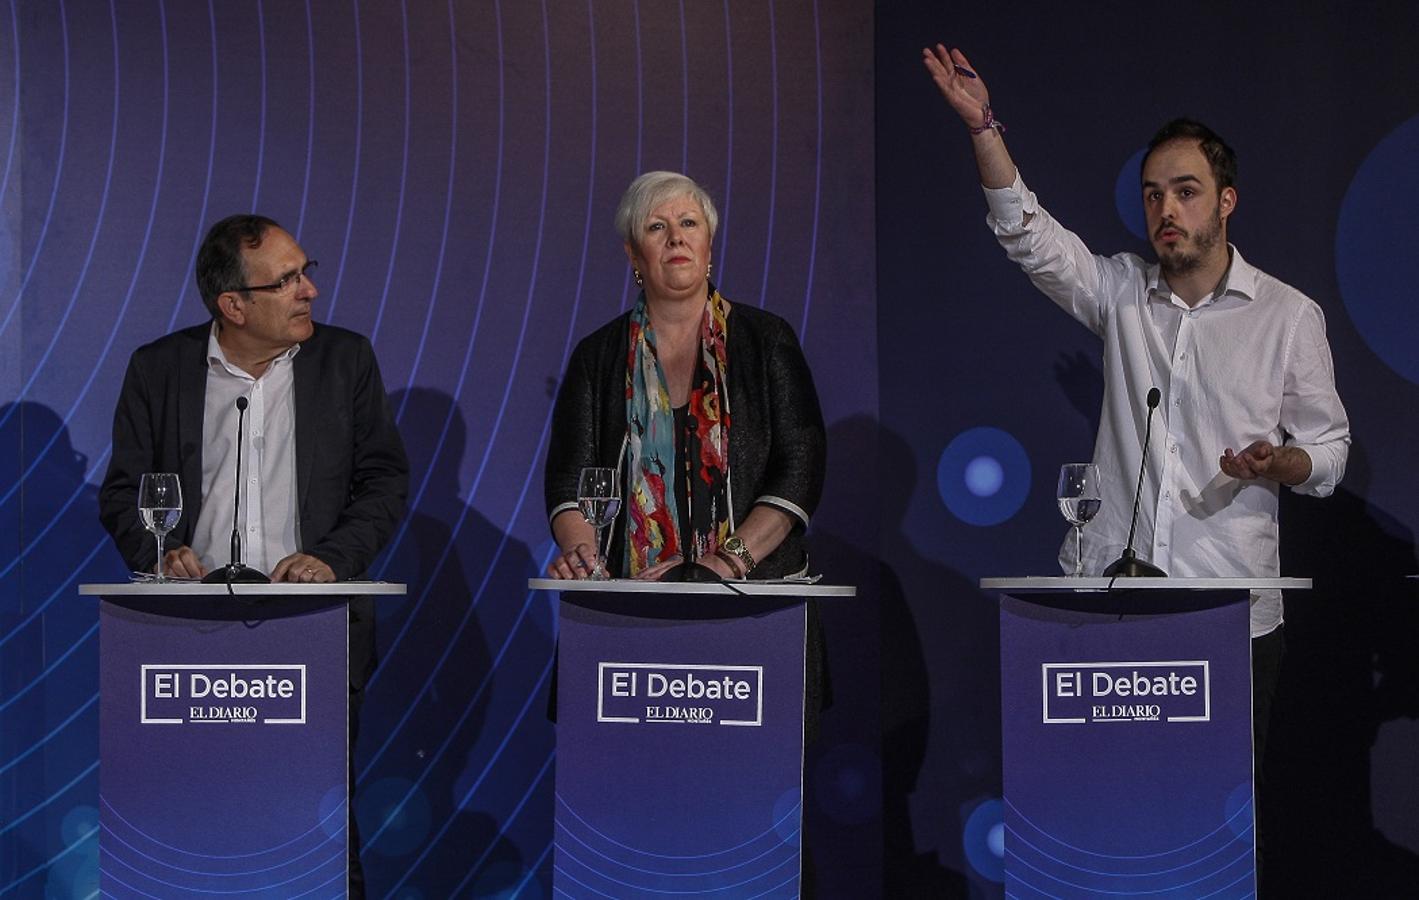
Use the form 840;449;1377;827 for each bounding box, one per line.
981;576;1311;900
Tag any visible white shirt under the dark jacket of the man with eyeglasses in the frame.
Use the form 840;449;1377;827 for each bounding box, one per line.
192;324;301;574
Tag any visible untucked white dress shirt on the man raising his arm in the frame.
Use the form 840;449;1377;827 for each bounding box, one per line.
985;175;1349;637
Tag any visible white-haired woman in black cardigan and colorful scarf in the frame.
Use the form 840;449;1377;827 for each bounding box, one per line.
546;172;826;579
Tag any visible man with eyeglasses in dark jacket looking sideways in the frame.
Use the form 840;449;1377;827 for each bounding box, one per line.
99;214;409;896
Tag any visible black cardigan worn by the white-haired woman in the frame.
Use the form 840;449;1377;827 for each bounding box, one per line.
545;304;827;578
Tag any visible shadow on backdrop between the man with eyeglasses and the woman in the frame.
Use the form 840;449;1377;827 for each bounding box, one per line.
356;388;553;897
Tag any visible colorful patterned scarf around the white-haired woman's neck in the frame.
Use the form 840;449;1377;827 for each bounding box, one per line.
623;285;729;576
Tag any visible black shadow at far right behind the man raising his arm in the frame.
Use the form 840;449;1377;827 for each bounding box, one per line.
1261;443;1419;897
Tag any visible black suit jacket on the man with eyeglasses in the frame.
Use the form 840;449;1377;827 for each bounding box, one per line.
99;322;409;688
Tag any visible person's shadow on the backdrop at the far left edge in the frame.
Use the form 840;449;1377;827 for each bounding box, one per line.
0;402;128;893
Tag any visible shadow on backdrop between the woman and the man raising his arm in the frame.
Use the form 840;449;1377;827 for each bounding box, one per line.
809;416;1000;900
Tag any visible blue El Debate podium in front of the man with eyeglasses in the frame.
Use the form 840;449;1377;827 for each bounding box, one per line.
79;582;404;897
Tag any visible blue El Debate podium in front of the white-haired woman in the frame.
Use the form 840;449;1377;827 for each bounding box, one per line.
529;579;856;900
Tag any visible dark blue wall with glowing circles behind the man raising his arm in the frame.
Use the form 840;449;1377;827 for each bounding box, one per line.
876;3;1419;896
